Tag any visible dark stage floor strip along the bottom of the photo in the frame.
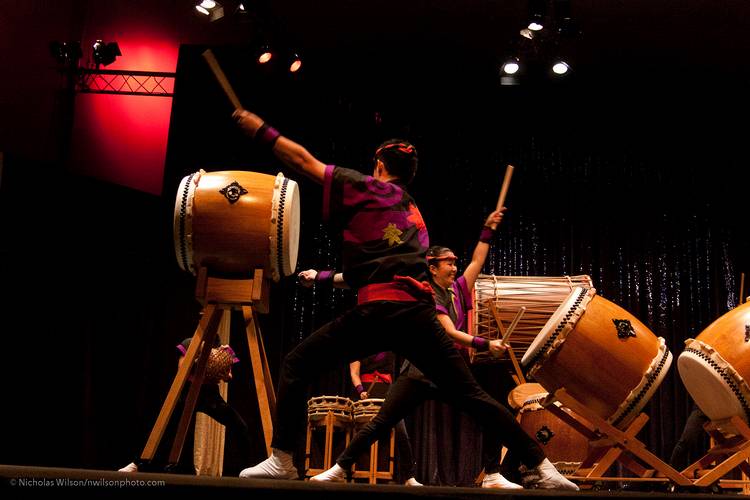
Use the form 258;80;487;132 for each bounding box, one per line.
0;465;741;500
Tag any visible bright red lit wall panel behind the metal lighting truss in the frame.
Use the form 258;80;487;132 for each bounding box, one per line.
70;6;179;195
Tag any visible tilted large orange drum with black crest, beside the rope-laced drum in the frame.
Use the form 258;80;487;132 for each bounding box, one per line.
521;287;672;428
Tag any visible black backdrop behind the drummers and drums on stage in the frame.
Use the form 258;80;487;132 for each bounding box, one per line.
0;2;750;484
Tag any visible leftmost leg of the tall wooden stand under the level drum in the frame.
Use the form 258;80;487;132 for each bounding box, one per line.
141;304;221;461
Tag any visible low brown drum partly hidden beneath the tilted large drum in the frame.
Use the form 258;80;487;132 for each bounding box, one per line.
519;392;589;474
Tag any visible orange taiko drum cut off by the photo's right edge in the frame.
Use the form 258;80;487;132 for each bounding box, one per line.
677;303;750;422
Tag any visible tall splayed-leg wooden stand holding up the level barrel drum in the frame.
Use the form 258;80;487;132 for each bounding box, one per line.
141;267;276;464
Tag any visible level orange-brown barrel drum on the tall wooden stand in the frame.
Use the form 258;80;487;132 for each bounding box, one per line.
174;170;300;281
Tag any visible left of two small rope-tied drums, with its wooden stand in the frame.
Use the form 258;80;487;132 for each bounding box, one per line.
305;396;353;479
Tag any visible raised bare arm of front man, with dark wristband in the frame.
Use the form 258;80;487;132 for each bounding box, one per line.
232;109;326;184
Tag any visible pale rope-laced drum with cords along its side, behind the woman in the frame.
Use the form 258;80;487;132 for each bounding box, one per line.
469;274;593;363
